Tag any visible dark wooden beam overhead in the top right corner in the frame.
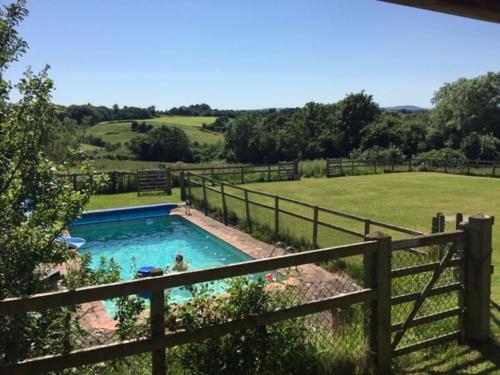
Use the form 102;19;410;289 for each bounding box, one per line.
379;0;500;23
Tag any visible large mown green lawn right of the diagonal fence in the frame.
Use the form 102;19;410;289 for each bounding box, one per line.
239;172;500;301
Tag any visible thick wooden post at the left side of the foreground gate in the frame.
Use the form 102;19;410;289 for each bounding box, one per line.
363;233;392;374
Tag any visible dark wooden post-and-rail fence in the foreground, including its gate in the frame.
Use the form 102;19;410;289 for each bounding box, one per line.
0;216;493;374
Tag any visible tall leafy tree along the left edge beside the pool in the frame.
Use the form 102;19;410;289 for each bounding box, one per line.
0;1;97;361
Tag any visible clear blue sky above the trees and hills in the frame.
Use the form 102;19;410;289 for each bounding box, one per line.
1;0;500;109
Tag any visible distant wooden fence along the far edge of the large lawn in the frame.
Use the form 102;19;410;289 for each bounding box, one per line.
326;159;500;177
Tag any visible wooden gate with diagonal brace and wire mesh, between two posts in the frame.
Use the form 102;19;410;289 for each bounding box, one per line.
392;235;464;354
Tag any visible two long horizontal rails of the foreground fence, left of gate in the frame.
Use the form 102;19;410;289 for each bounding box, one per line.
0;241;379;374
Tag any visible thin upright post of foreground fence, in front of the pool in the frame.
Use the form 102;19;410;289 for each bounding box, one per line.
151;269;167;375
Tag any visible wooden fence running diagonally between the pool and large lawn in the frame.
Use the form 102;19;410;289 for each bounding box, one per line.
181;172;423;249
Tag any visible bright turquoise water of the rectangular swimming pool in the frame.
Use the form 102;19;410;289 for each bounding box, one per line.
71;216;252;317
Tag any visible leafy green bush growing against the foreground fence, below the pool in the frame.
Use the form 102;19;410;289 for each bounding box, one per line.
169;278;320;374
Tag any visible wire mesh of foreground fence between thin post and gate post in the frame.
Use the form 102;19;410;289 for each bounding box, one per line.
167;265;367;374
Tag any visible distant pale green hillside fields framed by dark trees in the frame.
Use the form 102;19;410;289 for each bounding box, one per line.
87;116;224;151
